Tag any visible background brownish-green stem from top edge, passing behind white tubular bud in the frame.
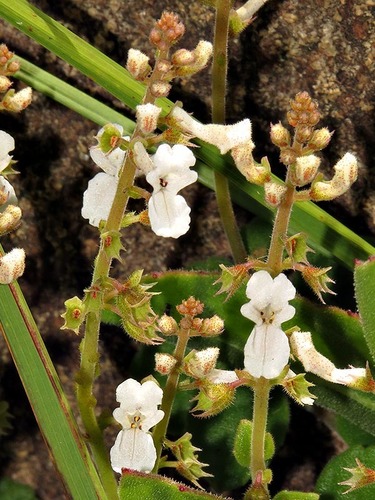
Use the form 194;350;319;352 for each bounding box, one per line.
212;0;247;263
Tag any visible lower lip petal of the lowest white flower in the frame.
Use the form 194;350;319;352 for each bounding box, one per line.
110;429;156;473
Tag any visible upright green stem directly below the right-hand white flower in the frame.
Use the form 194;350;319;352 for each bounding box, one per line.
250;377;270;490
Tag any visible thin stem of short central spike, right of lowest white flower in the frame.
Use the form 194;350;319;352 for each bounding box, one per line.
153;329;190;473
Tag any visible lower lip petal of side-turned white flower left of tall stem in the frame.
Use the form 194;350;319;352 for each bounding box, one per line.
81;172;118;227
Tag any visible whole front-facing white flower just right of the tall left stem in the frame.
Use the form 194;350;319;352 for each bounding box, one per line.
146;144;198;238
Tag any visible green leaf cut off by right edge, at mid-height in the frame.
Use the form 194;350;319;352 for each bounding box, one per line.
354;259;375;362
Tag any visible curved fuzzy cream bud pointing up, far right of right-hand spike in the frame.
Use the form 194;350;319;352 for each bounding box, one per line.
310;153;358;201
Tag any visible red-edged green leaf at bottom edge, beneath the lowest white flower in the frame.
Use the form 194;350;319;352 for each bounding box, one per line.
119;471;229;500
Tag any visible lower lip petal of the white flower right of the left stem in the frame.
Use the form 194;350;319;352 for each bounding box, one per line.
148;191;191;238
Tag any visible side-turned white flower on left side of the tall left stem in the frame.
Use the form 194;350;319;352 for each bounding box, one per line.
81;124;129;227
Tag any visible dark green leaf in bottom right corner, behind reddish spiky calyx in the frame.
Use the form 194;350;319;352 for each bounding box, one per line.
316;446;375;500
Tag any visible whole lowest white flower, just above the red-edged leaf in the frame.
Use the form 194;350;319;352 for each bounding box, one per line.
110;379;164;473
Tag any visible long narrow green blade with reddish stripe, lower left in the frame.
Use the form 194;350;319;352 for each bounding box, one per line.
0;276;107;500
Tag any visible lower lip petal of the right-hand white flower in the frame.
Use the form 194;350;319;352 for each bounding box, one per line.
245;324;290;379
